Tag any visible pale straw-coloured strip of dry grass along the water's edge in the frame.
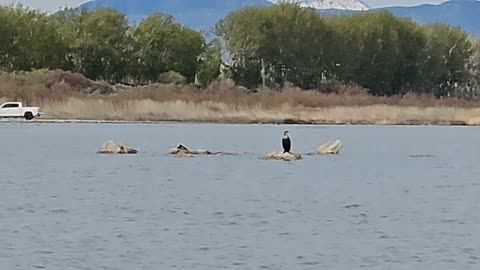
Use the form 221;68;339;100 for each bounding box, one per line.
38;98;480;124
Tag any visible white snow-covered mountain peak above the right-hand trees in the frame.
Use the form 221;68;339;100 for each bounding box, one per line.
268;0;370;10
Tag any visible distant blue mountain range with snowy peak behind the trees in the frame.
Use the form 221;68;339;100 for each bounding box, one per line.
79;0;480;35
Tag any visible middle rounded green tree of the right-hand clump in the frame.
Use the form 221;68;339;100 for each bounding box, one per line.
337;11;425;95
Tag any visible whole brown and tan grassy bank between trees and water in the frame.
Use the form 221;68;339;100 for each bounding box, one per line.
0;71;480;125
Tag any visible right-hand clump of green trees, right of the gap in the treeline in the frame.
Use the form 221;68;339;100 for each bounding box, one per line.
216;4;480;96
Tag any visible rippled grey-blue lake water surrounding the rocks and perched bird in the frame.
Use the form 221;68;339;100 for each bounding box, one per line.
0;123;480;270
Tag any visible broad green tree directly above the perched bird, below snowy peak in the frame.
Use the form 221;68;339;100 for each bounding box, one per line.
216;4;335;88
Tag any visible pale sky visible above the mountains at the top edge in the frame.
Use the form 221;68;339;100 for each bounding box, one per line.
0;0;450;11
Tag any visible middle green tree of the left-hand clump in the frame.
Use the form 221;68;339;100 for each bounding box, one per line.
61;8;133;82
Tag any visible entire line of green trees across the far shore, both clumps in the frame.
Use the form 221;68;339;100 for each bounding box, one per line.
0;4;480;97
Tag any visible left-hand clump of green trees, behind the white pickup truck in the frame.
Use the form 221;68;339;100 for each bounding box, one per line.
0;7;221;85
